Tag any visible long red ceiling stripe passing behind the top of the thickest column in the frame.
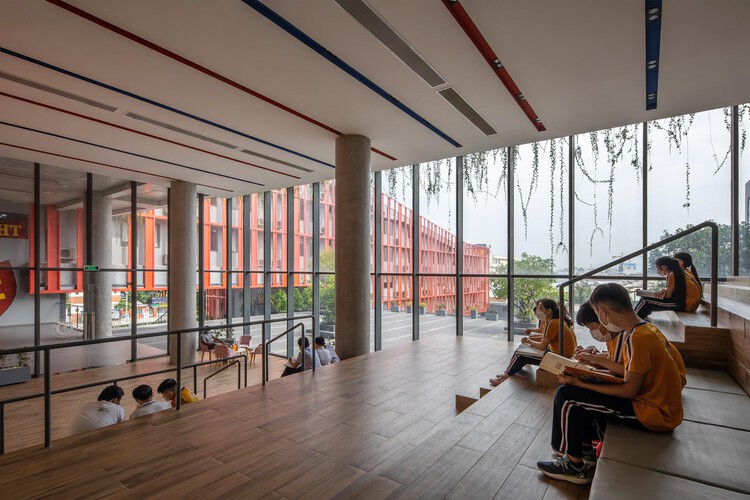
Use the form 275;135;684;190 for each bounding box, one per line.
47;0;396;160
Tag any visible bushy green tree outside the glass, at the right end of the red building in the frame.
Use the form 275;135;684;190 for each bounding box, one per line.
490;252;558;323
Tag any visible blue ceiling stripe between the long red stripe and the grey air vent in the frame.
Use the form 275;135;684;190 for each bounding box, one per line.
242;0;461;148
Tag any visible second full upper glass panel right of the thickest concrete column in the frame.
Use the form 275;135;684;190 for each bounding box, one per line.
419;158;456;273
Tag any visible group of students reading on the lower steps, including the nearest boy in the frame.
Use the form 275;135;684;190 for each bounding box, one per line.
500;283;686;484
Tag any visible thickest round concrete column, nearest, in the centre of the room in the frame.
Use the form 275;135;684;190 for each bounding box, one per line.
336;135;370;359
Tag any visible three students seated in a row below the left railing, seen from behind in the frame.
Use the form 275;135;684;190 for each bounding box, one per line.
71;378;198;434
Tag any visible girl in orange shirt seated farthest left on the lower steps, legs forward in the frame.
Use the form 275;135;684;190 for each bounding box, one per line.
490;299;577;386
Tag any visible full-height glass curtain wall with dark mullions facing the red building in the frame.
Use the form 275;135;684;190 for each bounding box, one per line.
0;101;750;374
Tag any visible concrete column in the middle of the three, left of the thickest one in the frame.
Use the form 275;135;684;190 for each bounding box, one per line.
169;181;198;364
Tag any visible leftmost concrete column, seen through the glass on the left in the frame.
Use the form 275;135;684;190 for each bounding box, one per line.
83;193;112;339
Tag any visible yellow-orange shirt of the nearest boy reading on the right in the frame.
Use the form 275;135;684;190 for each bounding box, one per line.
621;323;683;432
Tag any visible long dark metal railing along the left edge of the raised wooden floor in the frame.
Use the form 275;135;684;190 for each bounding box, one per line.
0;314;315;454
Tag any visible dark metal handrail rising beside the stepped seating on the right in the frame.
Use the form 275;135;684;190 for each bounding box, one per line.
557;221;719;355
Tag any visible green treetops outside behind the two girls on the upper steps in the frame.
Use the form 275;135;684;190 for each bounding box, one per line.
648;222;750;279
